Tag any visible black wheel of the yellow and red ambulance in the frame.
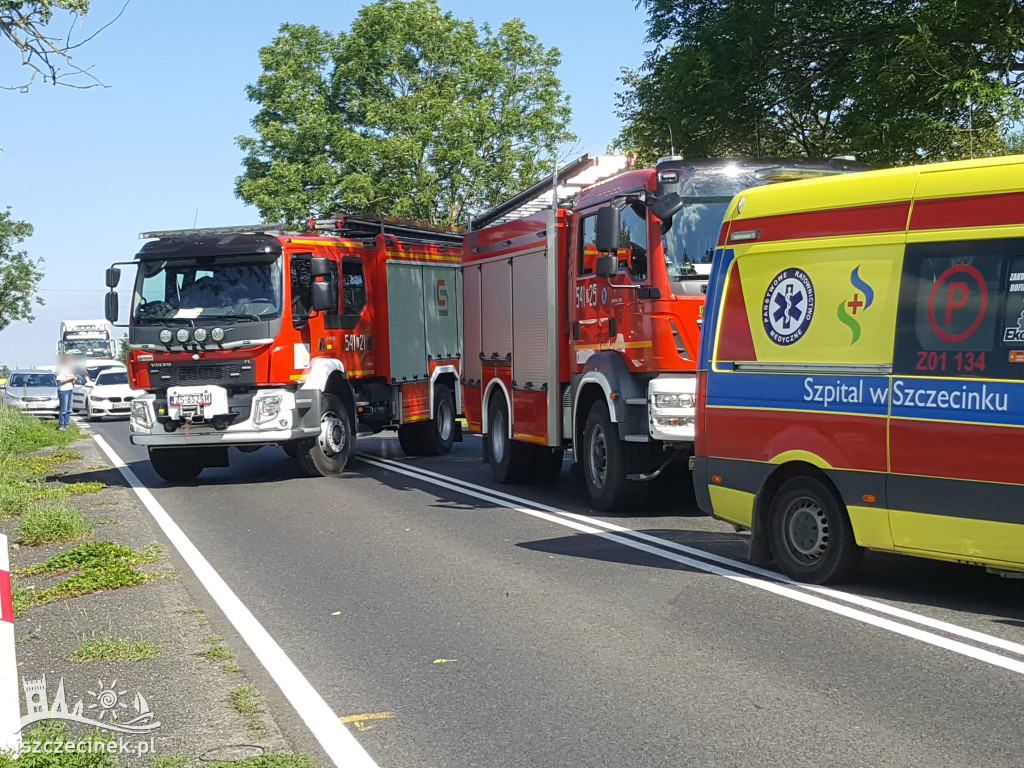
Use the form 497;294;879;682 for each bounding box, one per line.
768;476;864;584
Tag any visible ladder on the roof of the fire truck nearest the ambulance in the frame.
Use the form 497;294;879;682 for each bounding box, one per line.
469;153;634;230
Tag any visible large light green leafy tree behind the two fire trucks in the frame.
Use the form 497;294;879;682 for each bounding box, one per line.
236;0;573;225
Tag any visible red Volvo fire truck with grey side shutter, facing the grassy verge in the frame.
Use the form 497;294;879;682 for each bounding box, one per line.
106;216;463;481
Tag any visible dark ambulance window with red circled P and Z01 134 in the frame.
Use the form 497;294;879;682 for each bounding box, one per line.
893;240;1024;379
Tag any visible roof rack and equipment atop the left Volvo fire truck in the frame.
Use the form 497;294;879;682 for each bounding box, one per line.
138;213;463;246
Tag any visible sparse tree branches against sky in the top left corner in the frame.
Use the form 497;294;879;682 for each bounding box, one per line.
0;0;128;91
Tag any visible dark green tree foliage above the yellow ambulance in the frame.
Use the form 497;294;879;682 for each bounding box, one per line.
617;0;1024;165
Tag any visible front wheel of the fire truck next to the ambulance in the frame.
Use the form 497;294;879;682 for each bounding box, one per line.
580;402;636;512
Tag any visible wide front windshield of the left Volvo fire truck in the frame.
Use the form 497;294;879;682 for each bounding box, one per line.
132;256;282;325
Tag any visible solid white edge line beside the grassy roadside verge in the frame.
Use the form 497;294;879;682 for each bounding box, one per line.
92;434;378;768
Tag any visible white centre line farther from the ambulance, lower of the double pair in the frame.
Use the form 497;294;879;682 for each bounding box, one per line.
359;454;1024;675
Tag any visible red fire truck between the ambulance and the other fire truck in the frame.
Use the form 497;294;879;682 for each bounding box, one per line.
462;155;856;511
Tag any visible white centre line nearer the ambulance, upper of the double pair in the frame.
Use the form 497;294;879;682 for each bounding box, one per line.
362;457;1024;656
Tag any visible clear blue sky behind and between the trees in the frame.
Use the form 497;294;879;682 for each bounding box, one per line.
0;0;646;367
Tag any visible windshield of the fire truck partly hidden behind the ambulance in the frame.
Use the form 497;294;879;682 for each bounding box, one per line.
662;169;764;281
